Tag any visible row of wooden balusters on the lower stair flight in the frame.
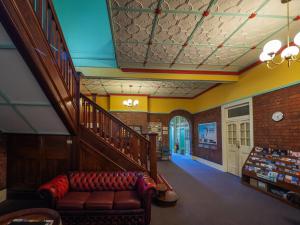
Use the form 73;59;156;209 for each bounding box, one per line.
80;94;150;169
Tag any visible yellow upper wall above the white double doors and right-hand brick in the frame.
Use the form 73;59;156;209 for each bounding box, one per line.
191;63;300;113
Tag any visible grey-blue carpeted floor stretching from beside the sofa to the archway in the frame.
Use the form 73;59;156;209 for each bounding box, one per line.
151;155;300;225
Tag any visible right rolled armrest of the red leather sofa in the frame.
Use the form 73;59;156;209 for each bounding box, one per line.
137;175;156;224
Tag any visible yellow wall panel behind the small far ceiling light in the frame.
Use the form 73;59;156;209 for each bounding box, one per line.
109;95;148;112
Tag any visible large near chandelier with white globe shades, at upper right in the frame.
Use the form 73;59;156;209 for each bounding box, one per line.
259;0;300;69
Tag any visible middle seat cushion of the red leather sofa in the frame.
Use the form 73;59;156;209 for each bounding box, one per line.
85;191;115;209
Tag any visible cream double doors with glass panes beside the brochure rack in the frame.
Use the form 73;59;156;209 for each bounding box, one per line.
226;119;251;176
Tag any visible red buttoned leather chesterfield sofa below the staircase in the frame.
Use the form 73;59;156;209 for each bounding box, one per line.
38;172;155;225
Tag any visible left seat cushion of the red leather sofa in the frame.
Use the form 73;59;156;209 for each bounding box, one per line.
56;192;90;209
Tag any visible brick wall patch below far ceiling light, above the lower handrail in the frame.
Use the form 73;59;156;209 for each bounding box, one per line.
111;112;148;133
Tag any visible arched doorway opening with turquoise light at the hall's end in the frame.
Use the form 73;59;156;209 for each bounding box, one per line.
169;116;191;155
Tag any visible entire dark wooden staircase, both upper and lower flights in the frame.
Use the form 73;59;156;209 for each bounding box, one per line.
0;0;176;206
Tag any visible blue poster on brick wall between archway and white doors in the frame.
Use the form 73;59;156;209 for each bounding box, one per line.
198;122;217;149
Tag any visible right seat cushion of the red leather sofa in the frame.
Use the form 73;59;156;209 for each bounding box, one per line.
114;191;141;209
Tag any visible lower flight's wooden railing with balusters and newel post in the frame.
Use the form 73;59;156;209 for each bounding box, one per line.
79;94;157;181
